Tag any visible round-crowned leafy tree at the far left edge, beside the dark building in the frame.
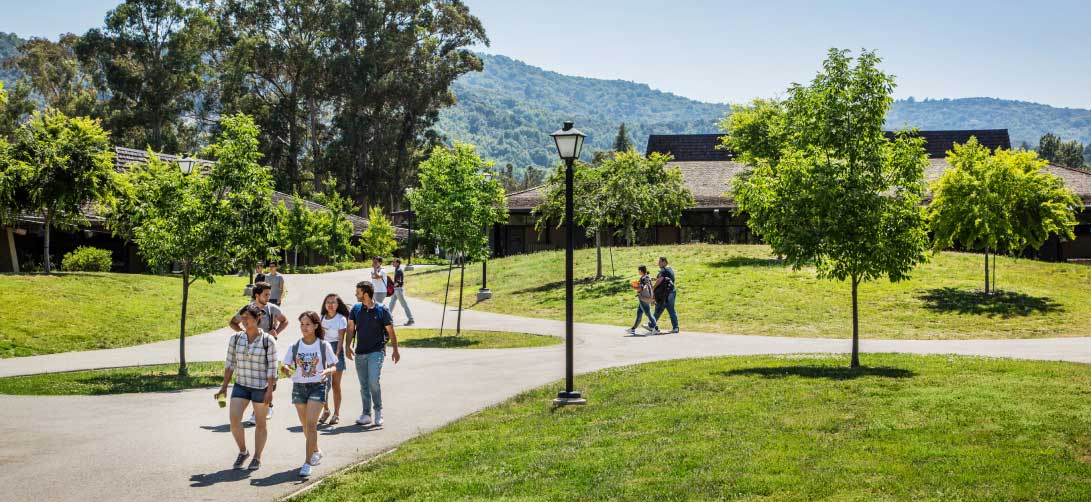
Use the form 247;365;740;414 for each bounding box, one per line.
4;110;113;274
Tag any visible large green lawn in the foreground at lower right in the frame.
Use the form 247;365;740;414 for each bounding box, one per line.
300;355;1091;501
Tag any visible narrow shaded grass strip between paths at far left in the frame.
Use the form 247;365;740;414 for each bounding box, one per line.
0;361;224;401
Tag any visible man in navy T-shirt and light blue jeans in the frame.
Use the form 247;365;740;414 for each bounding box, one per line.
346;280;401;426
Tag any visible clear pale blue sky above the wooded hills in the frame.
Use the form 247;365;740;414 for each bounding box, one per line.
0;0;1091;108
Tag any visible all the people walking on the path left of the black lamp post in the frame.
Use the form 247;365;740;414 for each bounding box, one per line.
216;259;412;477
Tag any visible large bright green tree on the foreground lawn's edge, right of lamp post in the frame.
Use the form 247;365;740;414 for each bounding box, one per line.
726;49;927;368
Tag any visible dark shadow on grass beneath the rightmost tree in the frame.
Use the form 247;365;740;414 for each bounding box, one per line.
918;287;1062;319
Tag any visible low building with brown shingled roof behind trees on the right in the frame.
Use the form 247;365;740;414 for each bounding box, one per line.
490;129;1091;260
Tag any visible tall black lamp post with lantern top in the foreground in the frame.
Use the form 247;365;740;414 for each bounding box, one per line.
550;122;587;406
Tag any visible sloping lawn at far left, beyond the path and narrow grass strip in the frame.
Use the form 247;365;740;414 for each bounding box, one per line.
0;273;247;358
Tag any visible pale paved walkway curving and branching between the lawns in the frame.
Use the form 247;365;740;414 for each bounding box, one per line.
0;271;1091;501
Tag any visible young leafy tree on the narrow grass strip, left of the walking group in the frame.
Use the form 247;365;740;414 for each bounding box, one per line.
108;115;275;375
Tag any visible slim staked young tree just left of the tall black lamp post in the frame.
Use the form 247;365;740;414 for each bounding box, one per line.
408;143;507;333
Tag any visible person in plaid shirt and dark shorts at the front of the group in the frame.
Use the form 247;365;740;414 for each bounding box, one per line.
216;303;277;470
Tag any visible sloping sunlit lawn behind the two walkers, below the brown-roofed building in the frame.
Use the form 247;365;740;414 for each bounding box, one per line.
408;244;1091;339
